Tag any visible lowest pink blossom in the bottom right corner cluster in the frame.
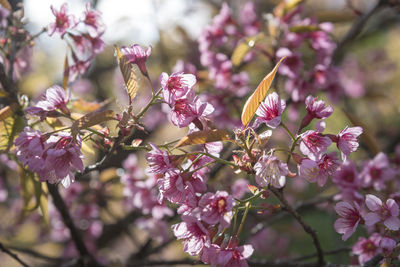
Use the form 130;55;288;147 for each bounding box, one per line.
353;233;382;264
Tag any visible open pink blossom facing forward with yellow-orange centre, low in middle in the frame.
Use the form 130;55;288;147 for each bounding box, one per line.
198;191;234;229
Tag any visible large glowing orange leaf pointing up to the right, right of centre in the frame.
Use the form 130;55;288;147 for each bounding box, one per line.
242;57;285;127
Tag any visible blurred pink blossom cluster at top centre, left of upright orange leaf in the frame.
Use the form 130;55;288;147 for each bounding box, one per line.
198;2;261;127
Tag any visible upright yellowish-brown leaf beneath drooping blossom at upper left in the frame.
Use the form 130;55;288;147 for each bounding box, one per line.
115;46;139;104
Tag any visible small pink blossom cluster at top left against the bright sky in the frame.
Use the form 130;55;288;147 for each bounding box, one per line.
47;2;106;82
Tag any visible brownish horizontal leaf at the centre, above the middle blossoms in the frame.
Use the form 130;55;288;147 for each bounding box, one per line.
175;130;230;147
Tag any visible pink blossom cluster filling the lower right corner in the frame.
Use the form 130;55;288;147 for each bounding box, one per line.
332;149;400;264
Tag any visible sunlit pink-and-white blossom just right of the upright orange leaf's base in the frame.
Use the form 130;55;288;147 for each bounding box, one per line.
254;92;286;129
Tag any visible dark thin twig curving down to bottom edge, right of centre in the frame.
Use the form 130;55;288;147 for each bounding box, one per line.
269;187;324;266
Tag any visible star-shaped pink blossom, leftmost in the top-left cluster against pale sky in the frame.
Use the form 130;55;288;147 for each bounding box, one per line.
47;3;76;37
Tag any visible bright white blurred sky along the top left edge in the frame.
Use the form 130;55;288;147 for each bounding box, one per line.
24;0;210;45
